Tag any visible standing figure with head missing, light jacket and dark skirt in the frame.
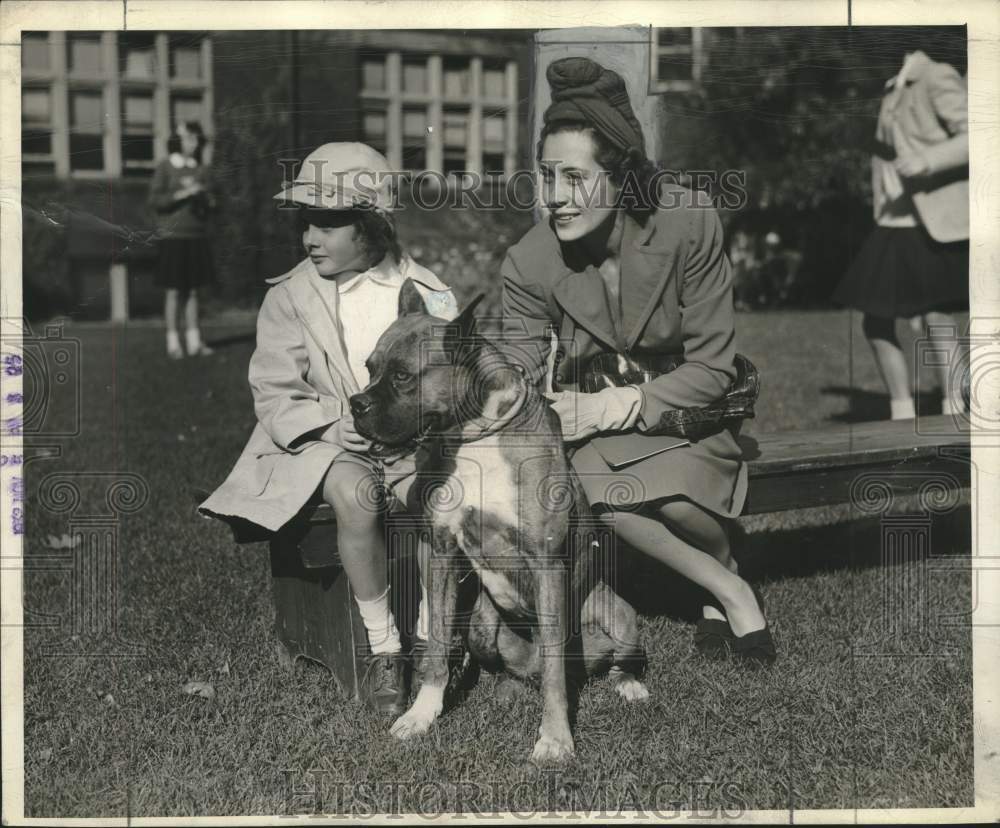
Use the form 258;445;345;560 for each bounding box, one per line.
833;50;969;420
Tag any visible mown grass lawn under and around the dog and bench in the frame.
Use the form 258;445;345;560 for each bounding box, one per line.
24;312;973;817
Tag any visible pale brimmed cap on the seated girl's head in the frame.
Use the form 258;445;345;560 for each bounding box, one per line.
274;142;393;212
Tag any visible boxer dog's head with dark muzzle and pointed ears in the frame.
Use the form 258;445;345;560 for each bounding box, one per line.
350;279;478;451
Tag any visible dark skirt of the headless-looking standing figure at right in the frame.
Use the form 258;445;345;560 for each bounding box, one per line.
833;227;969;319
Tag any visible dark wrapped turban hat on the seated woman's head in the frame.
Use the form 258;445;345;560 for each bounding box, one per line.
544;57;646;155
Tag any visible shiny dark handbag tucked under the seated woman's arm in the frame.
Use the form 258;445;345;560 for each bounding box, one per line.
580;352;760;440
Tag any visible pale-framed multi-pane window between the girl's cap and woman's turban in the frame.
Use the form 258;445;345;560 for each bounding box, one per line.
359;51;518;181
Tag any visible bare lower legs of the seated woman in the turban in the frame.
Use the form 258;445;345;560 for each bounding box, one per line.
604;501;766;636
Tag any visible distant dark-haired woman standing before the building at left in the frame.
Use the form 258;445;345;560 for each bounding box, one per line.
149;121;215;359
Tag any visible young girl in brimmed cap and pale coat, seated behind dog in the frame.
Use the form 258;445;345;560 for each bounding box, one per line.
201;143;457;714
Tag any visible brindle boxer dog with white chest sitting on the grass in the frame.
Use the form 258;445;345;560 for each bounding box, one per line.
350;280;649;763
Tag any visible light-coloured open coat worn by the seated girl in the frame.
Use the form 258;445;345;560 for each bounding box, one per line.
199;254;453;531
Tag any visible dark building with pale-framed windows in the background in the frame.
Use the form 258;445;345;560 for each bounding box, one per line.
21;29;703;317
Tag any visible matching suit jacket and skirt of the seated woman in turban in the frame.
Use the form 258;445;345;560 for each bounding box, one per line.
502;186;747;516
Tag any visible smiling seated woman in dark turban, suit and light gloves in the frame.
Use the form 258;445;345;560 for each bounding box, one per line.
503;58;775;663
